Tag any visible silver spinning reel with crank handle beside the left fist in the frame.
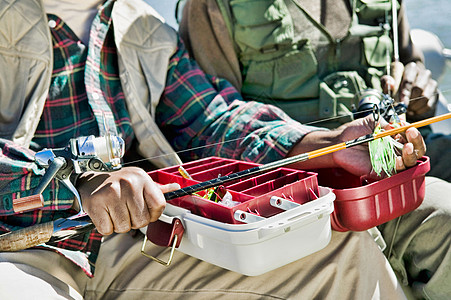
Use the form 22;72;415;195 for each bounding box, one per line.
13;134;125;215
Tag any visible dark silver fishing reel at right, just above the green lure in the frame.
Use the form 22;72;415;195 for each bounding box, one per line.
353;89;407;122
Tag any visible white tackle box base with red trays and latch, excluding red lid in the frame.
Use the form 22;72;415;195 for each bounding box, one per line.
146;157;335;276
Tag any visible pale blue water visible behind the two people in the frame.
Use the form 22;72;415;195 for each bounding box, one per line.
146;0;451;96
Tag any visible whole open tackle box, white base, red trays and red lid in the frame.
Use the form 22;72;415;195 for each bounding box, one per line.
147;157;429;276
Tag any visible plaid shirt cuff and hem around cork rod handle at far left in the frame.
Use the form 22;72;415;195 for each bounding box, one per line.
0;139;101;258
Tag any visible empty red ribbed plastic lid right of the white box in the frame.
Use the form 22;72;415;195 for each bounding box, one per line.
318;156;430;231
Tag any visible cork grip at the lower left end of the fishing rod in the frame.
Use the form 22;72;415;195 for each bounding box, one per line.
0;222;53;252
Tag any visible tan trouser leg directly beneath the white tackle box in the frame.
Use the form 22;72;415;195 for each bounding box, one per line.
84;232;404;300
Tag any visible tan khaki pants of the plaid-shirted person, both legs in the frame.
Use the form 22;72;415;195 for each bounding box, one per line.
0;232;404;300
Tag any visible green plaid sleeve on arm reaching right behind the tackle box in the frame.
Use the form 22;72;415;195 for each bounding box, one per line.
156;41;318;163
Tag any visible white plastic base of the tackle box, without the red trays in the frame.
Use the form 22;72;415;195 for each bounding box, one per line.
154;187;335;276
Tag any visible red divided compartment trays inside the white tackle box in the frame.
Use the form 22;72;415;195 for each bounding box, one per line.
148;157;319;224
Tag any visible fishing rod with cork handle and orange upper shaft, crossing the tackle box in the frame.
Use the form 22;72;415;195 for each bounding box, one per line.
0;113;451;251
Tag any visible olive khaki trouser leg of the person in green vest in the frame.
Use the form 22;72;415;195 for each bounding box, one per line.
379;177;451;299
